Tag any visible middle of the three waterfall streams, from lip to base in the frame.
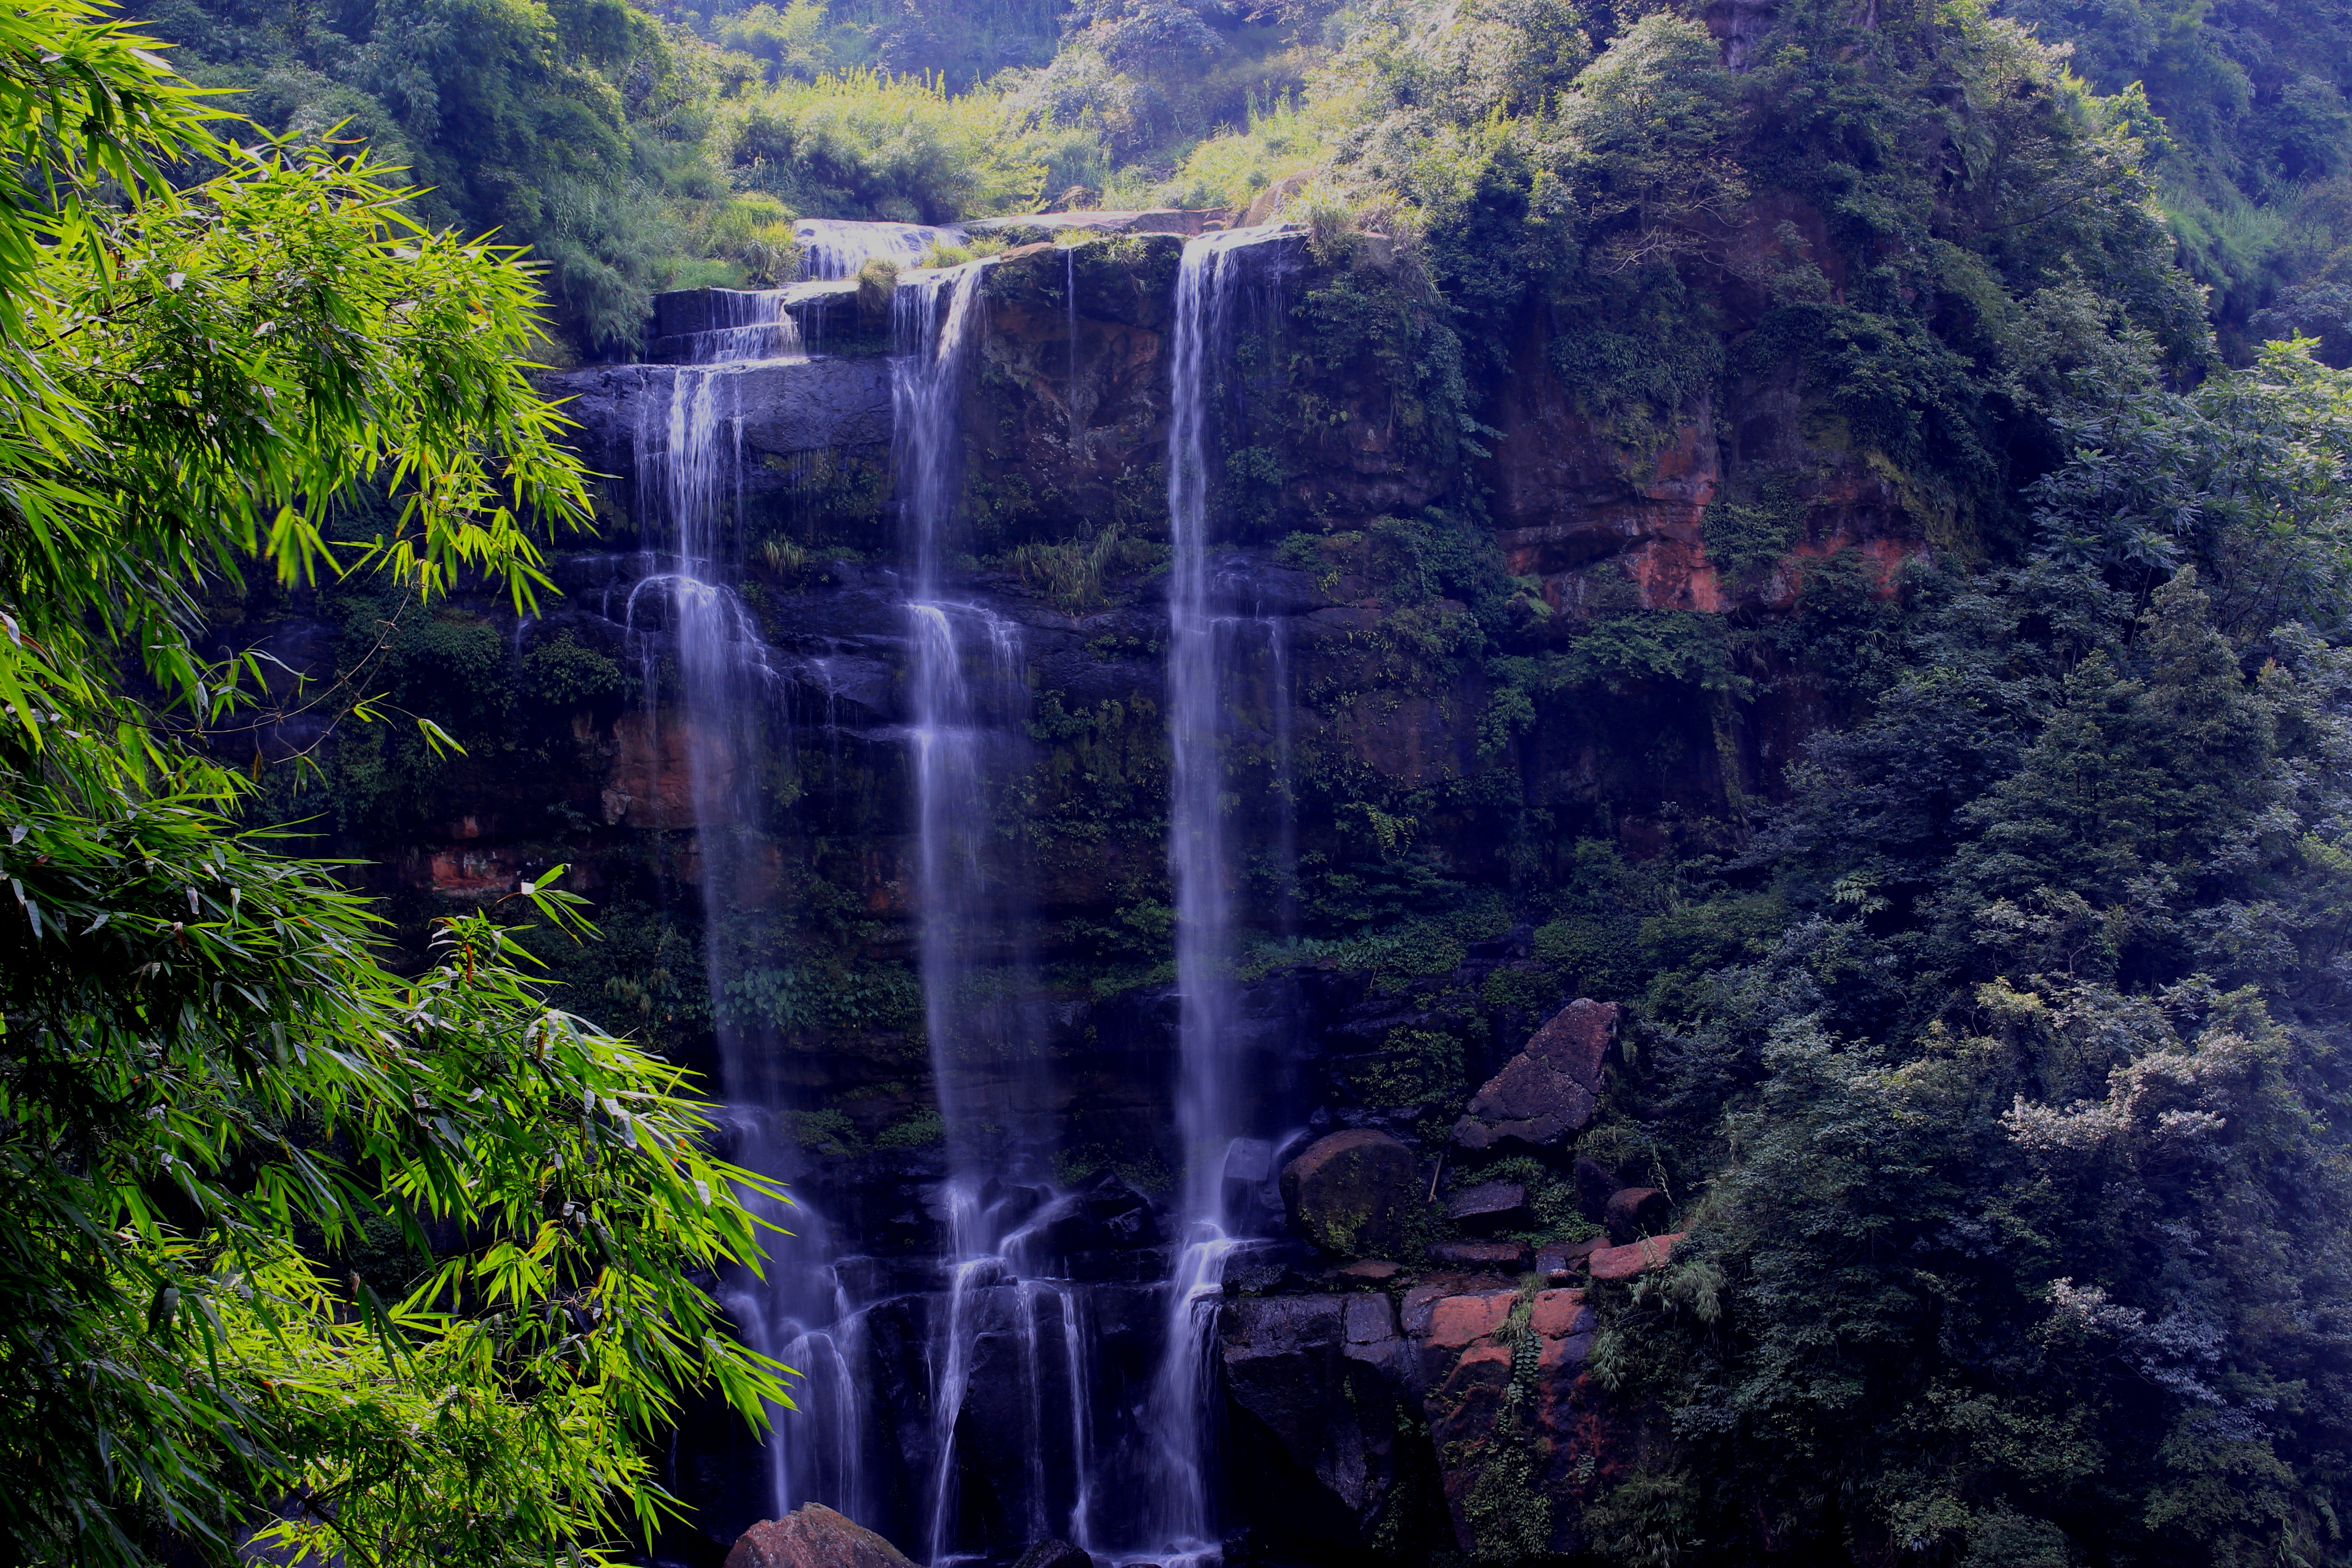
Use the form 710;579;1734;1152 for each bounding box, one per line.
892;261;1087;1566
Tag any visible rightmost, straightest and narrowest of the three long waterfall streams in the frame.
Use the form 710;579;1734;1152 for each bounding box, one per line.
1146;228;1265;1561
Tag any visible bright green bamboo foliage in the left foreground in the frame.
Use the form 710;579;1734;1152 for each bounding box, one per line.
0;0;785;1566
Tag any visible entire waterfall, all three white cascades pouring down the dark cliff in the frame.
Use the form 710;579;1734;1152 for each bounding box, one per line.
593;225;1291;1568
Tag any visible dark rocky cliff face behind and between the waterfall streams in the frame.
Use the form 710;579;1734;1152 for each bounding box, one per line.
228;214;1938;1561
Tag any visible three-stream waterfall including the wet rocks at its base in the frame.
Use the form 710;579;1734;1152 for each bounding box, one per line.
628;221;1289;1568
